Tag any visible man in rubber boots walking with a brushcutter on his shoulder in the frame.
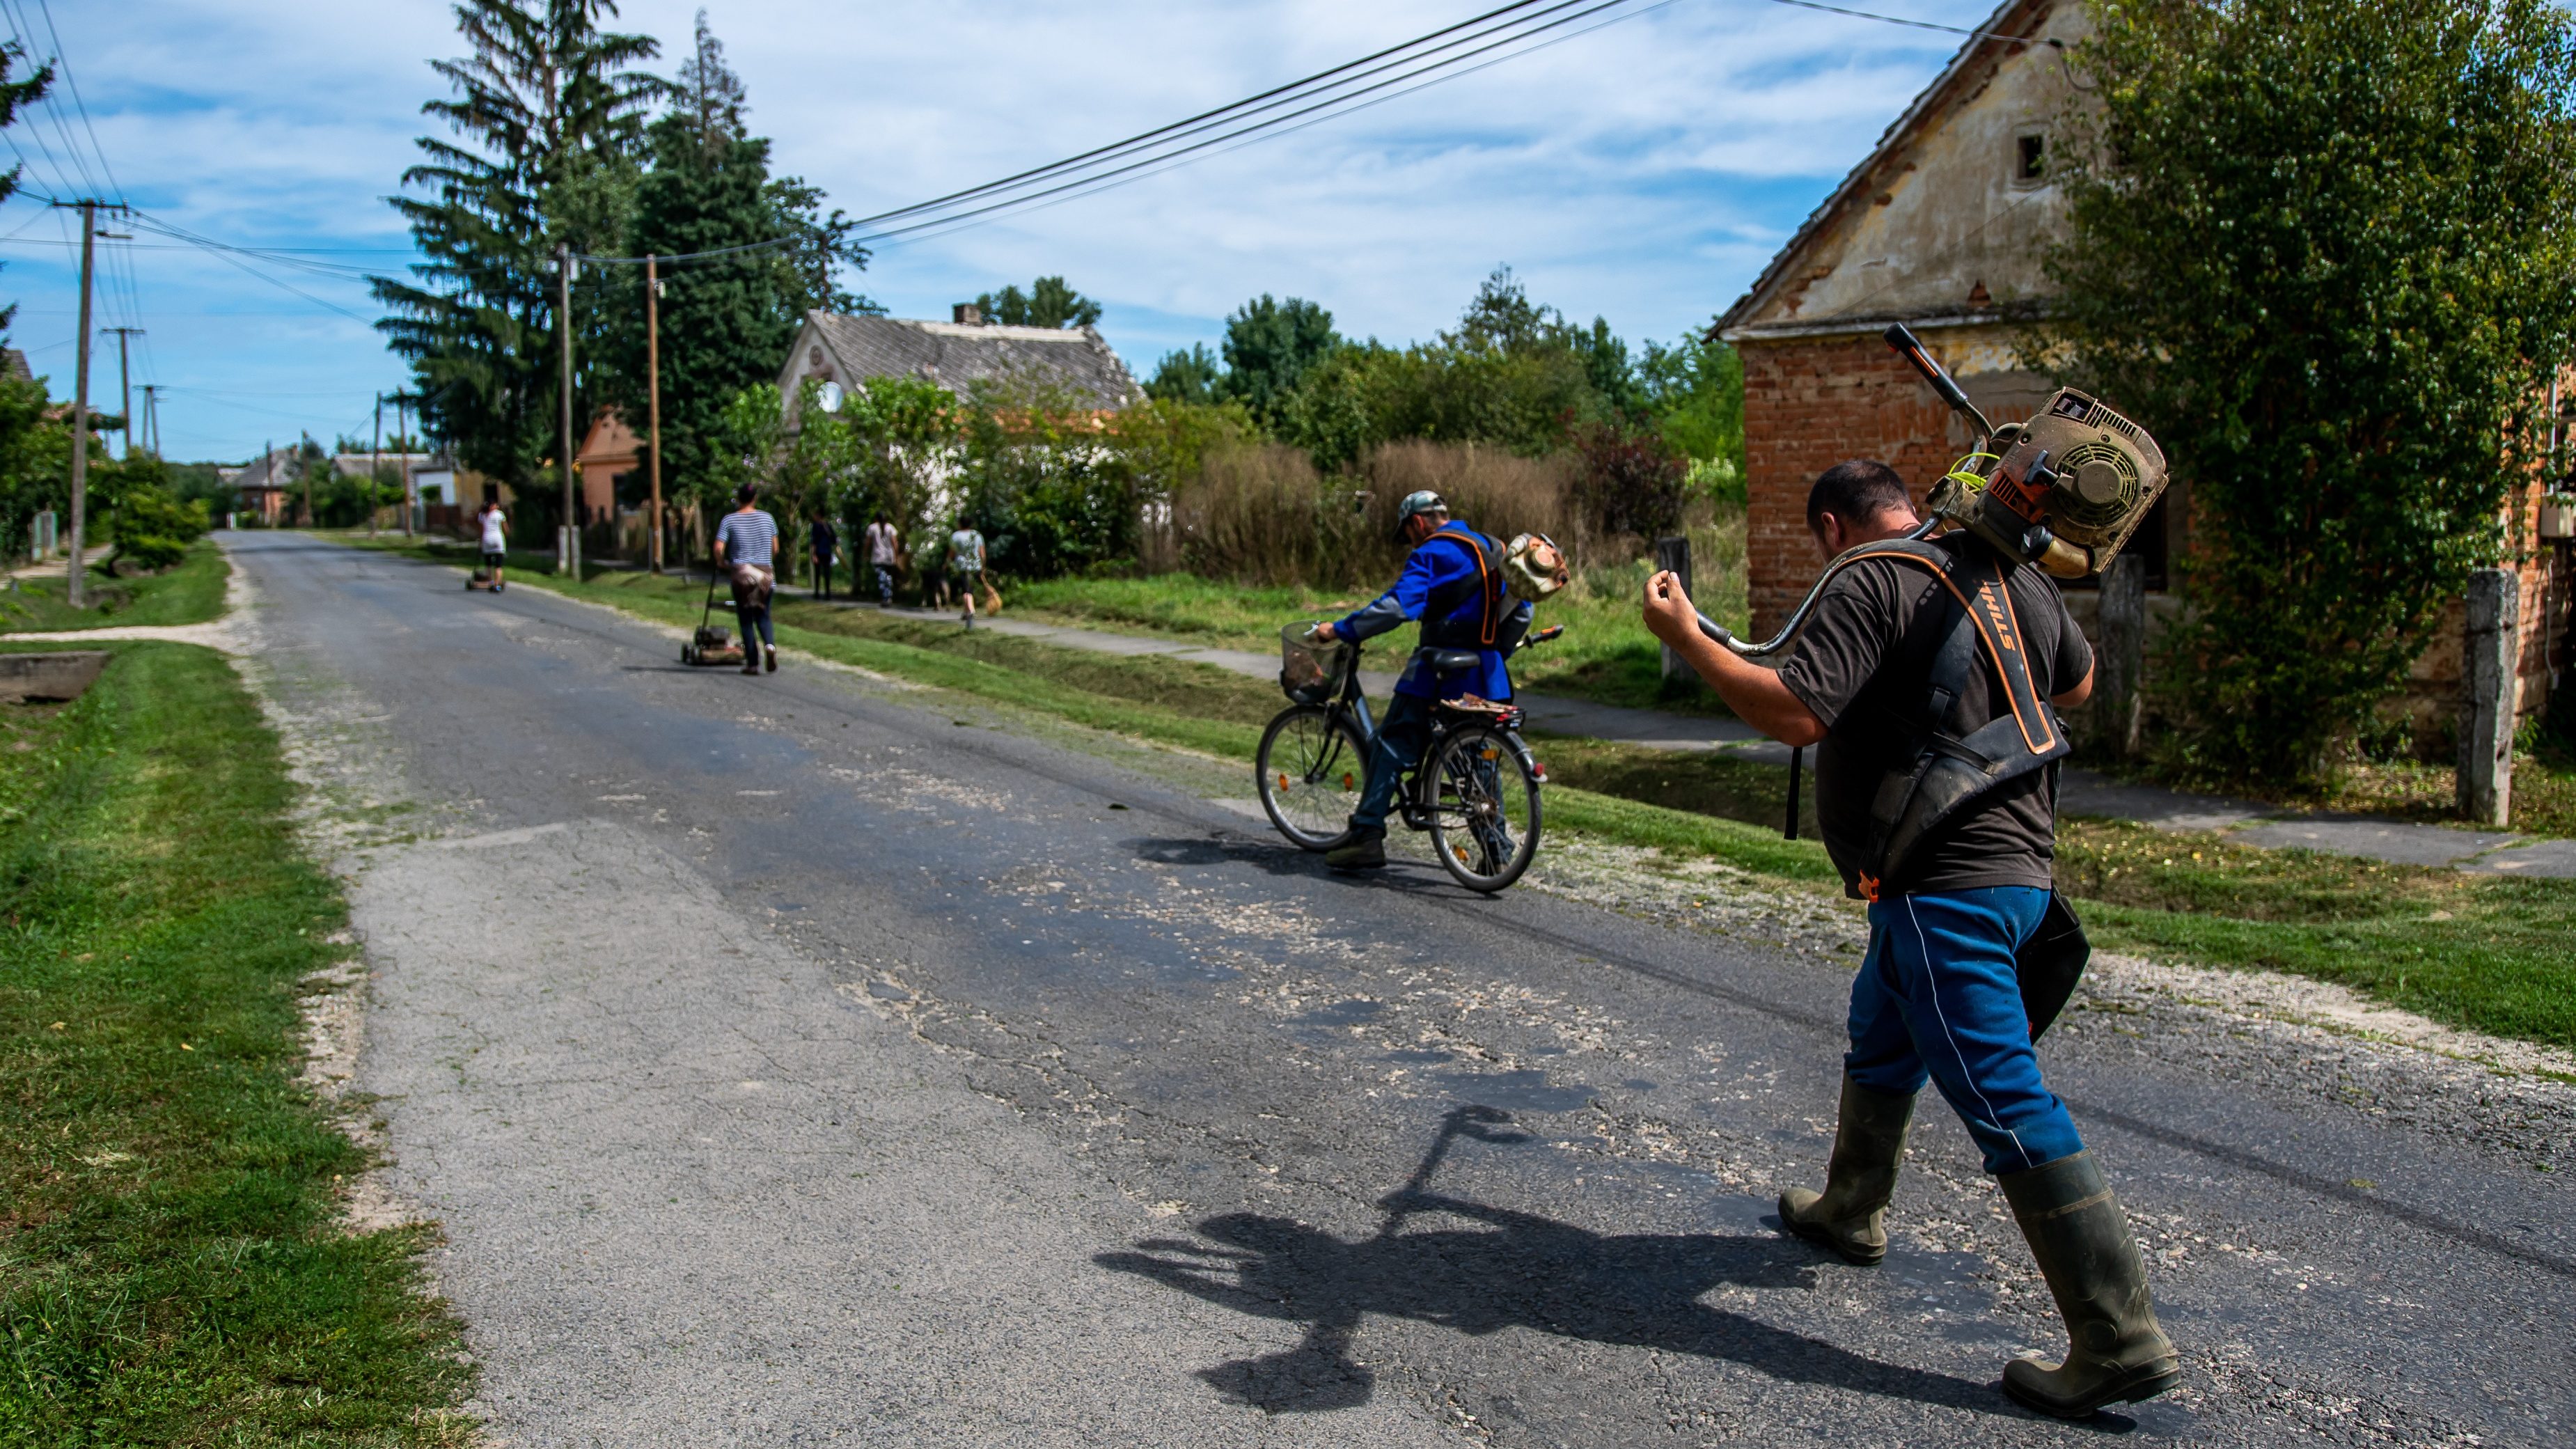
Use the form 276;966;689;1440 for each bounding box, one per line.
1644;327;2182;1418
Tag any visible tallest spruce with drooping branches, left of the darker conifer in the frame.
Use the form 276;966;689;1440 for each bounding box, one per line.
376;0;662;508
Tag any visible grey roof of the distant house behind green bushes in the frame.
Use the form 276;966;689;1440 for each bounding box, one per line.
778;301;1144;425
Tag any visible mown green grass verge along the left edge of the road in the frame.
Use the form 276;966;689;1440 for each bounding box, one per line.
0;645;471;1449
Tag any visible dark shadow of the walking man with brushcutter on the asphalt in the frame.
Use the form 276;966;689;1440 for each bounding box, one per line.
1095;1106;2020;1418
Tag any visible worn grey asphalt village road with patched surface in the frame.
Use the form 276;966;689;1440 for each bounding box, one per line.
229;533;2576;1446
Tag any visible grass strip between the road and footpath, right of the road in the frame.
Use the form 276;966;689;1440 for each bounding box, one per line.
347;531;2576;1047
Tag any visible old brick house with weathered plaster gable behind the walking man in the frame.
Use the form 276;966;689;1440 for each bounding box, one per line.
1718;0;2568;725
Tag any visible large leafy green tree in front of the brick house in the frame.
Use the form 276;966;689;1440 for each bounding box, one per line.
2045;0;2576;778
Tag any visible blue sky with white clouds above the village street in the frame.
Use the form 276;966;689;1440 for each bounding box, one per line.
0;0;1991;459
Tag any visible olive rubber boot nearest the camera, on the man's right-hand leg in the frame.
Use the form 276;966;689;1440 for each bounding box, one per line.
1997;1152;2182;1418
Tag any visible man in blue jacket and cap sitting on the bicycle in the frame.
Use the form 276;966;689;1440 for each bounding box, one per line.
1317;490;1530;872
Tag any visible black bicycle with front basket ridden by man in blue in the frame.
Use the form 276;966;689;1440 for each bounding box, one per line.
1255;624;1566;895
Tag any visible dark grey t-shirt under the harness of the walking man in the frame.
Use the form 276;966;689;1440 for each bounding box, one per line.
1780;539;2091;895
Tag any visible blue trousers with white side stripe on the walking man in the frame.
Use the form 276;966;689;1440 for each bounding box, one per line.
1842;887;2084;1173
